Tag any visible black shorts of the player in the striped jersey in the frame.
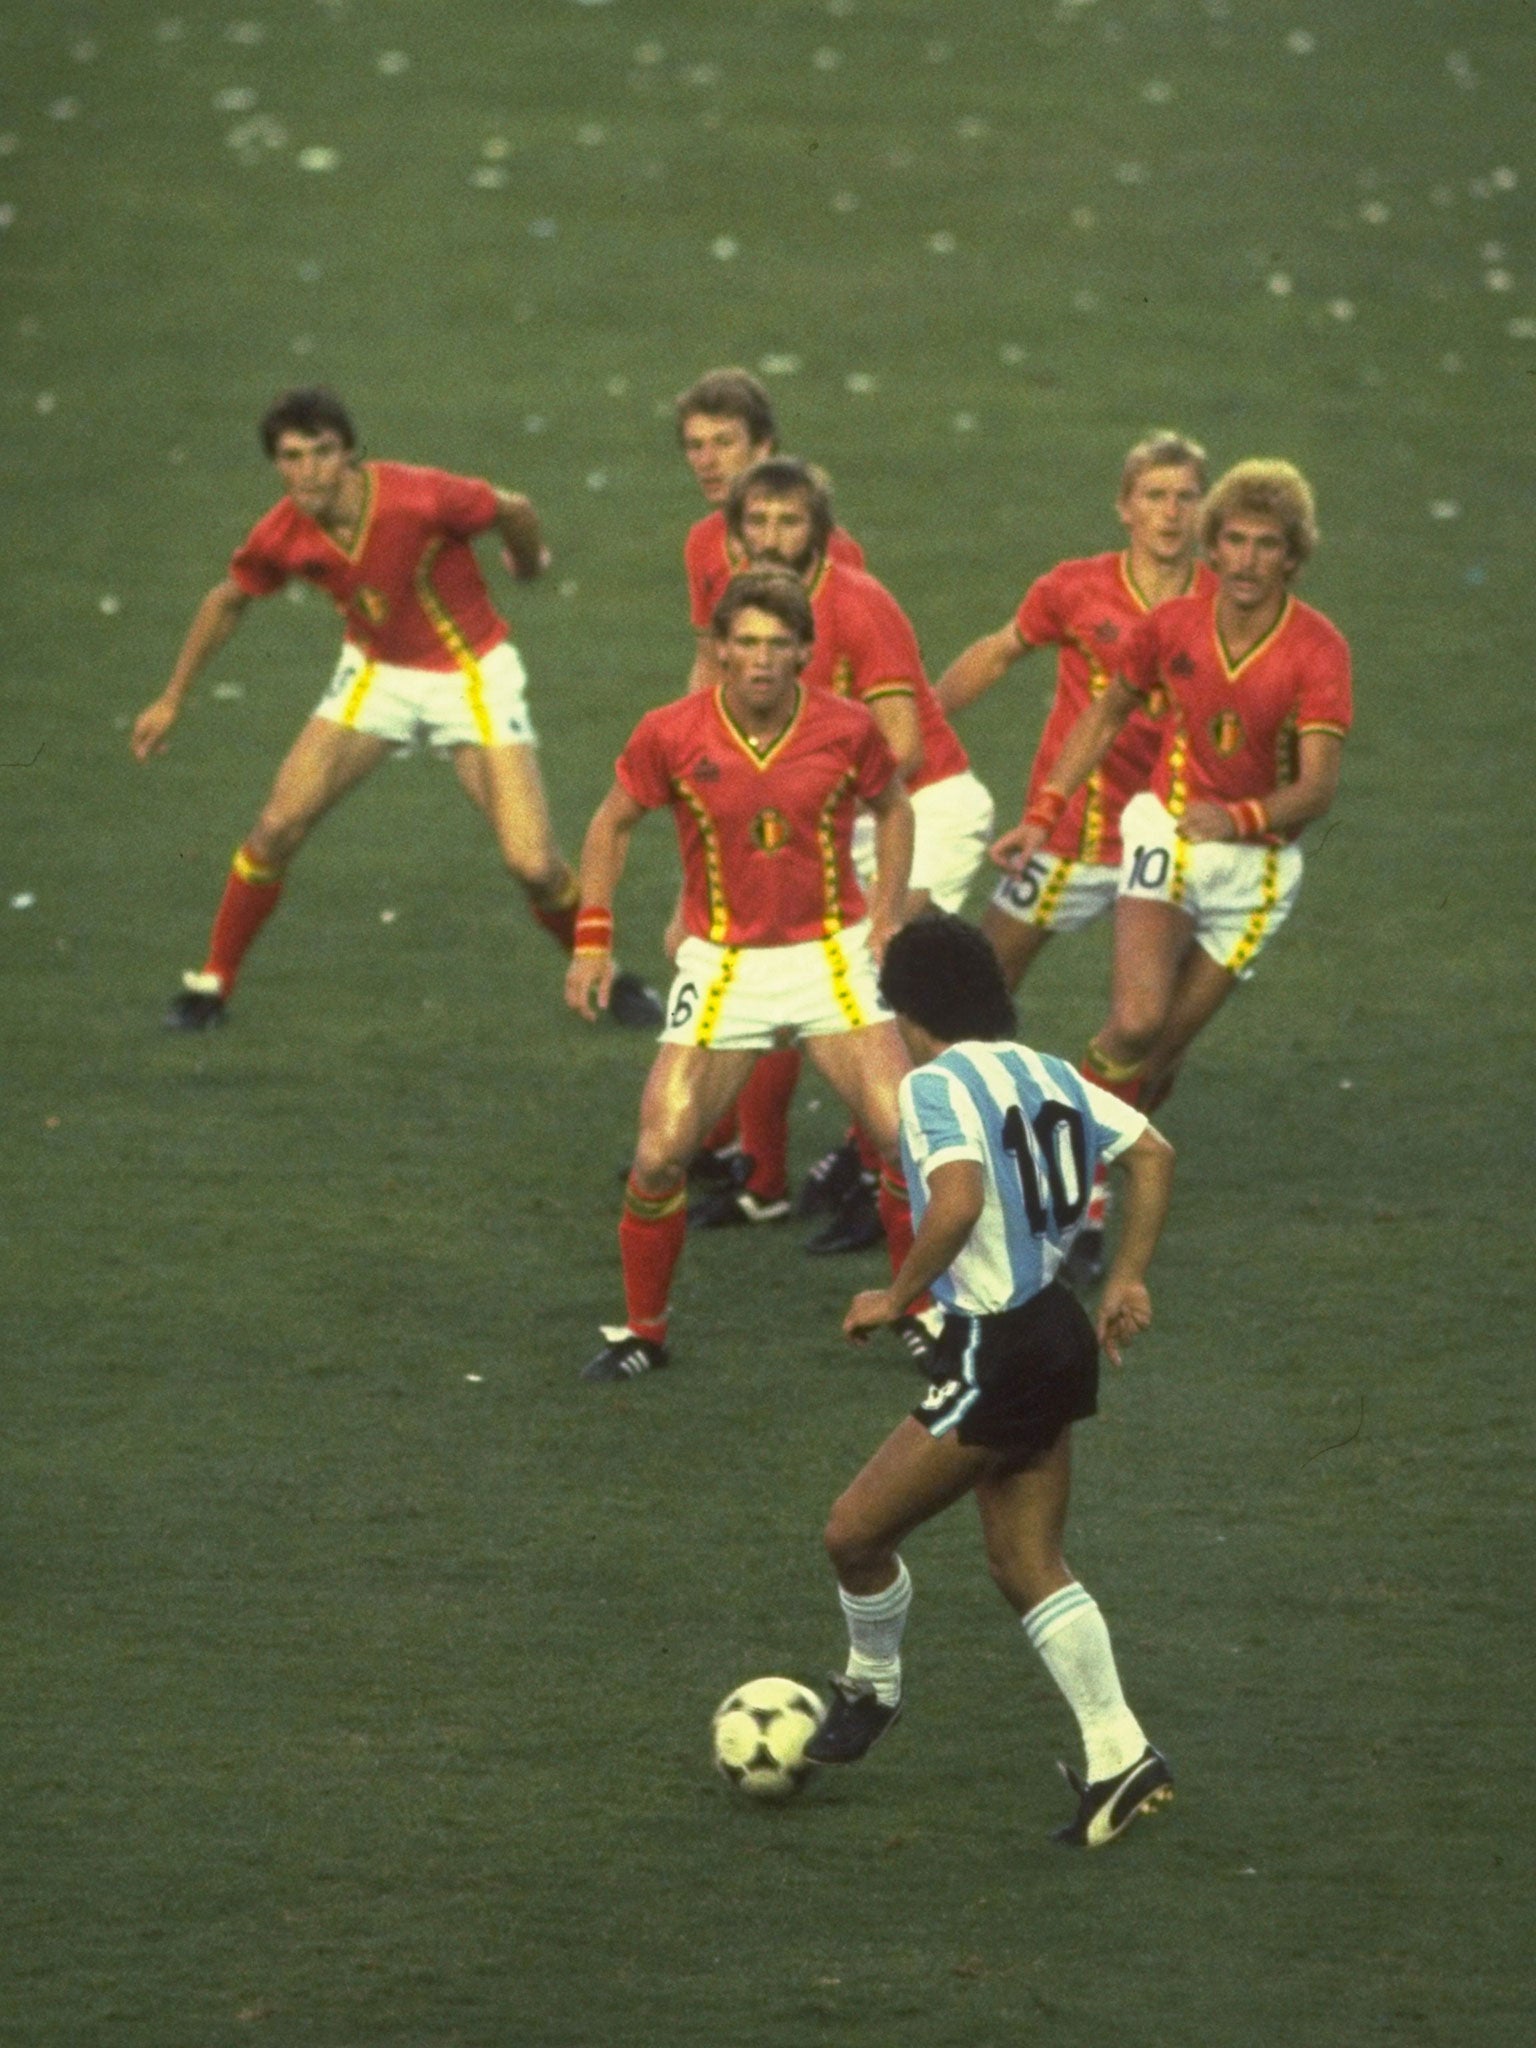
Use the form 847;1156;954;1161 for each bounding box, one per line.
911;1280;1098;1473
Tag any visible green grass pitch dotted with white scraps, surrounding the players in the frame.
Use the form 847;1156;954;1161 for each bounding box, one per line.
0;0;1536;2048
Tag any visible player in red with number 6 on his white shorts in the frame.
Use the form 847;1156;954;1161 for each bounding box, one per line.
565;571;928;1380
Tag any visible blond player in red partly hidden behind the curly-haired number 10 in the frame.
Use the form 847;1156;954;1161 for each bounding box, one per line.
934;428;1217;1286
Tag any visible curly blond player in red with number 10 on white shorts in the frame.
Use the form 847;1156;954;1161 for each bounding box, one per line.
991;461;1352;1187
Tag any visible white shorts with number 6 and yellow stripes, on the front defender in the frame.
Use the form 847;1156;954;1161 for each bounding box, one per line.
662;924;891;1053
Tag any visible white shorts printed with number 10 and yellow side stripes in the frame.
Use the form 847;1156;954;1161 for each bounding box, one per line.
1120;791;1303;977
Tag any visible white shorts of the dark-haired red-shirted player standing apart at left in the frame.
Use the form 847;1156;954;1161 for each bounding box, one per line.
315;641;539;752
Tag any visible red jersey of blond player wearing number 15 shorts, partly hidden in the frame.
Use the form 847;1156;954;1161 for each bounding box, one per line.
1014;551;1217;866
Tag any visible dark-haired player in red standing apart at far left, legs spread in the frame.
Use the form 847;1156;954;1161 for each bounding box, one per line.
131;389;662;1030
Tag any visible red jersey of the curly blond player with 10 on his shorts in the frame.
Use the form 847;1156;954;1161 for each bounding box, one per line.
1118;596;1354;842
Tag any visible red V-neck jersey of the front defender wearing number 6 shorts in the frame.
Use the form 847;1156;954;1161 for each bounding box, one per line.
614;688;897;946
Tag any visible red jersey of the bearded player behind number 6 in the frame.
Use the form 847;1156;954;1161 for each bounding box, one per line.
801;557;971;791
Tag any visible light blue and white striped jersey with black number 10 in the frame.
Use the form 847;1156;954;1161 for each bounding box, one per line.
901;1038;1147;1315
